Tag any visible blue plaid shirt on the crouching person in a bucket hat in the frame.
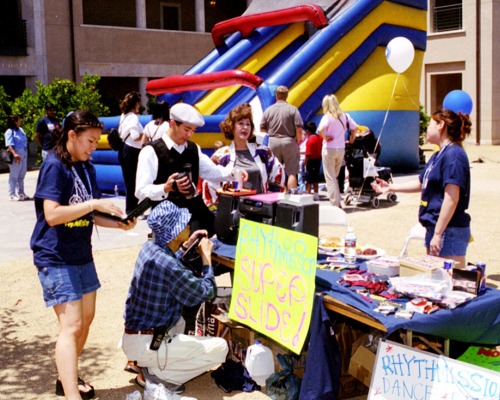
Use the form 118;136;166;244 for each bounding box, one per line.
124;241;217;331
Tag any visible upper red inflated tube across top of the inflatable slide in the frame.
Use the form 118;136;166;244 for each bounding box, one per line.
212;4;328;47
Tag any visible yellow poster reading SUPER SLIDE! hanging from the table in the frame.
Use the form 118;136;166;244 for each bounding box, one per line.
229;219;318;354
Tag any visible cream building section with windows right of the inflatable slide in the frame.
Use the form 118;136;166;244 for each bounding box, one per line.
420;0;500;145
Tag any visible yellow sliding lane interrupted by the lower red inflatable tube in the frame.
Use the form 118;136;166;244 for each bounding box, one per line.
196;22;304;115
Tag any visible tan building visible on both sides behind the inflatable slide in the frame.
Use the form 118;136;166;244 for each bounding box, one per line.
0;0;500;145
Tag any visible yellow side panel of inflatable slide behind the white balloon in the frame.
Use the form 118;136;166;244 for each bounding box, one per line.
338;48;424;113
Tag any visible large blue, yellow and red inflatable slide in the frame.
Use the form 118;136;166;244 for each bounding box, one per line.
94;0;427;191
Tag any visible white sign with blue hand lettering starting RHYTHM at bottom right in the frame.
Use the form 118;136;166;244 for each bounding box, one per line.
368;340;500;400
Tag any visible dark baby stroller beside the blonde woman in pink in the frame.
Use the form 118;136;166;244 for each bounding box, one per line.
344;129;397;208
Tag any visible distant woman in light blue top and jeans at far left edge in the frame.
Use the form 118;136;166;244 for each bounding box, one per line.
5;114;29;201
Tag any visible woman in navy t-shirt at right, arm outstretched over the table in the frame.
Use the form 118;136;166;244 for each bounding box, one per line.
372;109;472;268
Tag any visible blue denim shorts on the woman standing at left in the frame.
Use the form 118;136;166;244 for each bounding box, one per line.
37;262;101;307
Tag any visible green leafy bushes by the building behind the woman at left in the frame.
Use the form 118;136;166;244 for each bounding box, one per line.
12;74;109;140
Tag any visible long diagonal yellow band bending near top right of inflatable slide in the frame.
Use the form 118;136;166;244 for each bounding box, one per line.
288;2;427;107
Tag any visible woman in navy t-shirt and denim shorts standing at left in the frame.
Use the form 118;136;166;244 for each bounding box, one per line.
30;110;136;399
